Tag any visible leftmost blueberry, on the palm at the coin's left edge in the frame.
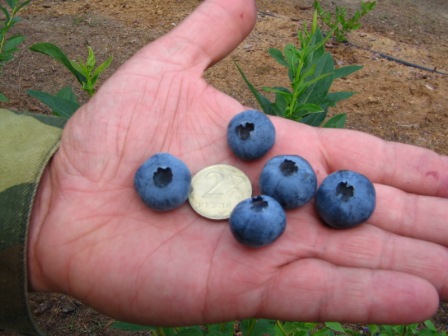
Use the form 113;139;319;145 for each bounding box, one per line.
134;153;191;211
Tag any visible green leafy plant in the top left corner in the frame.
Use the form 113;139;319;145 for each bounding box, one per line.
0;0;31;102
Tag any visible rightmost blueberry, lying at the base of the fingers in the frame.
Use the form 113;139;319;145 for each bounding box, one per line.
315;170;376;229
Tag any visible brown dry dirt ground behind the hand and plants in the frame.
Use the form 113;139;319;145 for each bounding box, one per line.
0;0;448;335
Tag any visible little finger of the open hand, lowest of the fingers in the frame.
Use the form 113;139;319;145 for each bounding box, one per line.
259;259;439;324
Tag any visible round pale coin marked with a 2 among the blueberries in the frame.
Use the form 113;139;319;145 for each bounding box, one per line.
188;164;252;220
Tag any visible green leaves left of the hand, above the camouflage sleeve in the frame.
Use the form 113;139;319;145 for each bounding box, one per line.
28;43;112;118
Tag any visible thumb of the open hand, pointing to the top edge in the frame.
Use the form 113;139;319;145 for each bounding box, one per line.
136;0;256;72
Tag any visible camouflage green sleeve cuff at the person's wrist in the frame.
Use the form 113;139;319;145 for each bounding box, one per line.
0;109;66;335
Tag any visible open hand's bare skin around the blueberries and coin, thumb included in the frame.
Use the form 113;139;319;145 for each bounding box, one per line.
28;0;448;325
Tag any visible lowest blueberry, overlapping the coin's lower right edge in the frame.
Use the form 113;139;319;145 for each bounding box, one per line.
229;195;286;247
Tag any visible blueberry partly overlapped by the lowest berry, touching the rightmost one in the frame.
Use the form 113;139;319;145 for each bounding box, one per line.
259;155;317;209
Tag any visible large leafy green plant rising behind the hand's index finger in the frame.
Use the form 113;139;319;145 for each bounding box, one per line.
236;12;362;128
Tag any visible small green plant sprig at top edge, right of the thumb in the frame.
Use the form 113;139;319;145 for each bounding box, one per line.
313;0;376;42
